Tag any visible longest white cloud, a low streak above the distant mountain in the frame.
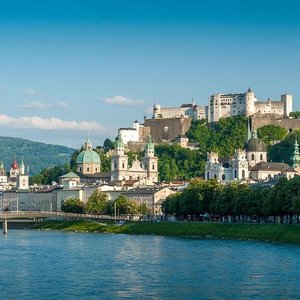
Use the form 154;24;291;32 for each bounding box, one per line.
0;115;104;132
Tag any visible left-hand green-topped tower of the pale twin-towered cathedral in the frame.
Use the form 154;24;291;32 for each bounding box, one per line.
111;134;128;181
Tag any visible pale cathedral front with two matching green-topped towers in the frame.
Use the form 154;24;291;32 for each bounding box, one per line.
111;135;158;185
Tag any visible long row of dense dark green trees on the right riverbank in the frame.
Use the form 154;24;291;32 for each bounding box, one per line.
163;176;300;223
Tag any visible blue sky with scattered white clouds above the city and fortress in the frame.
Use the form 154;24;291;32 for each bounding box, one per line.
0;0;300;148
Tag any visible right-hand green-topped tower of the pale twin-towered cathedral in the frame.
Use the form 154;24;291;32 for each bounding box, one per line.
142;136;158;183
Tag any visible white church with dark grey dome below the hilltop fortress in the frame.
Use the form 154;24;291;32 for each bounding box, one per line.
205;122;300;182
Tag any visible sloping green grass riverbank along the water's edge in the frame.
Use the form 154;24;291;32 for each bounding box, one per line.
34;220;300;244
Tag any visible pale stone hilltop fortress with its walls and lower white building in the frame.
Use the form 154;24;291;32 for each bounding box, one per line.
118;88;297;151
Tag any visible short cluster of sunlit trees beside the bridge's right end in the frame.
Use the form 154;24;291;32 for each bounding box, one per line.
61;190;149;216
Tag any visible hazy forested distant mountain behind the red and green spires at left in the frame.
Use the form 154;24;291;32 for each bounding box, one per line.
0;137;75;175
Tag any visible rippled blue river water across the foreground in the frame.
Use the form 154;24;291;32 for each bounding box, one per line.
0;230;300;299
